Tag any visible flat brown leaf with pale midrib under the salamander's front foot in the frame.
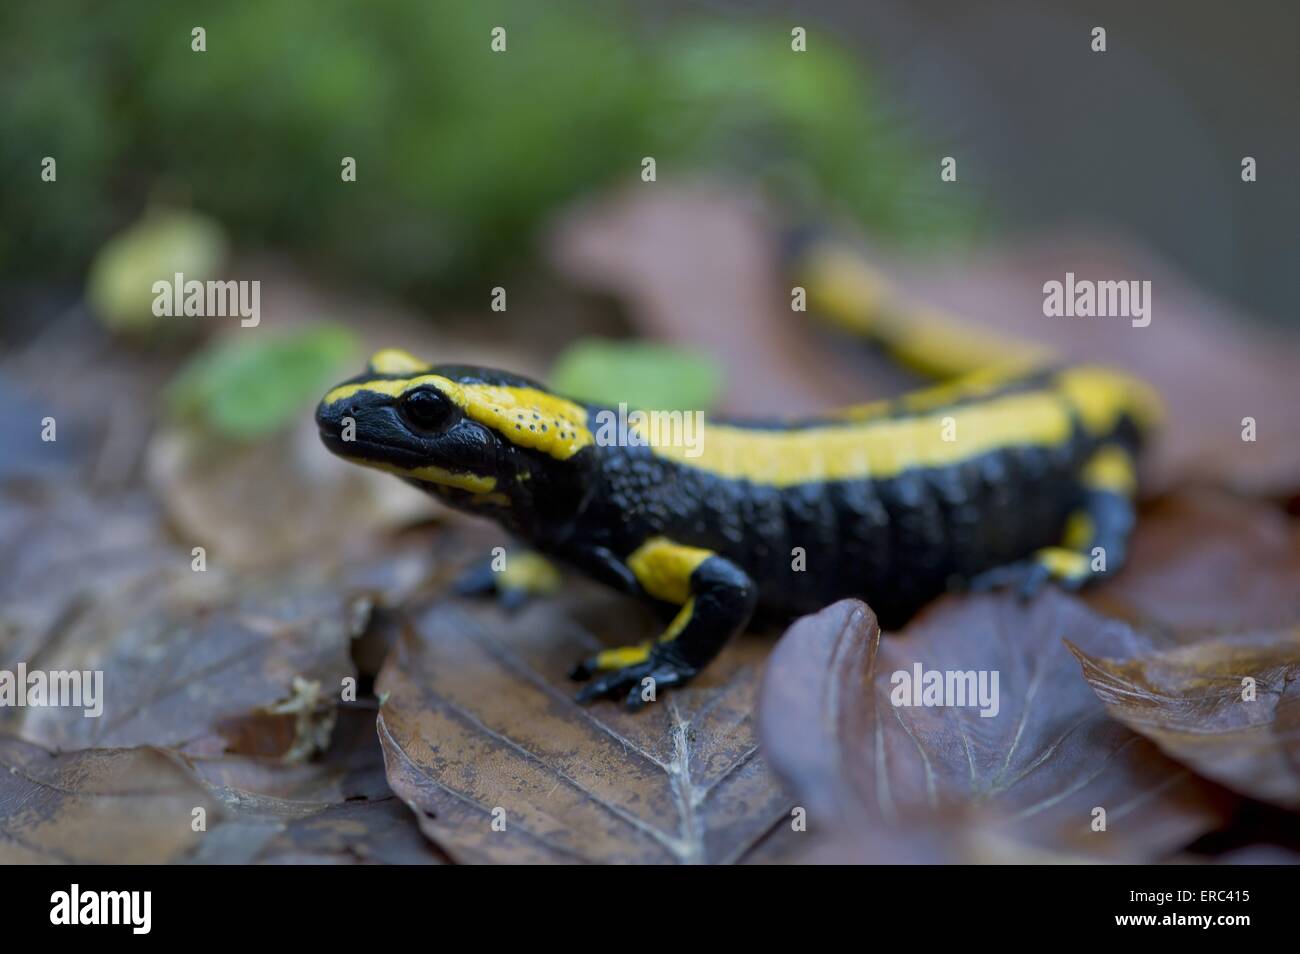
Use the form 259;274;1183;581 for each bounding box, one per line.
377;585;790;863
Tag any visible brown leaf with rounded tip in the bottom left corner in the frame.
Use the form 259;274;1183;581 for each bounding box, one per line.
0;736;224;864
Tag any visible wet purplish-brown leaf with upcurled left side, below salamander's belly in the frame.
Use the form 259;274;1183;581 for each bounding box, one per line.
761;591;1226;862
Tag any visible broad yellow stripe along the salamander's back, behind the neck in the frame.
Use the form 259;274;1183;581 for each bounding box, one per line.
642;391;1074;486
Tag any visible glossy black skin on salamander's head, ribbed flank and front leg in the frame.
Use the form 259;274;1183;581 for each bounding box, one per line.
317;365;1138;707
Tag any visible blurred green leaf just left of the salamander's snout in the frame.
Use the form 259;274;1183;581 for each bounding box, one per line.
168;324;359;441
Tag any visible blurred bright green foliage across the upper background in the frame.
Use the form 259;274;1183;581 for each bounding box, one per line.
0;0;967;294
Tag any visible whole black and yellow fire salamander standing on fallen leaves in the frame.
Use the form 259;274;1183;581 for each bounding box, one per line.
316;232;1160;708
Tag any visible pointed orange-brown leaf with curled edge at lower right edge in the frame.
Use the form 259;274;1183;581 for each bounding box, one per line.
1071;628;1300;808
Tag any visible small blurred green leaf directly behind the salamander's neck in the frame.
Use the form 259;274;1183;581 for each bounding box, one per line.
550;338;723;411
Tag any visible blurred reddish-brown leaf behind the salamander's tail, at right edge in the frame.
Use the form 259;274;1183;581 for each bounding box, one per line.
900;235;1300;496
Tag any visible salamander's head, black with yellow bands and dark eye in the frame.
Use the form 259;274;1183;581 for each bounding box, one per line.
316;350;593;503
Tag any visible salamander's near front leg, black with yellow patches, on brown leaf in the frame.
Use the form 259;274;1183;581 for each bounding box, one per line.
571;537;758;710
